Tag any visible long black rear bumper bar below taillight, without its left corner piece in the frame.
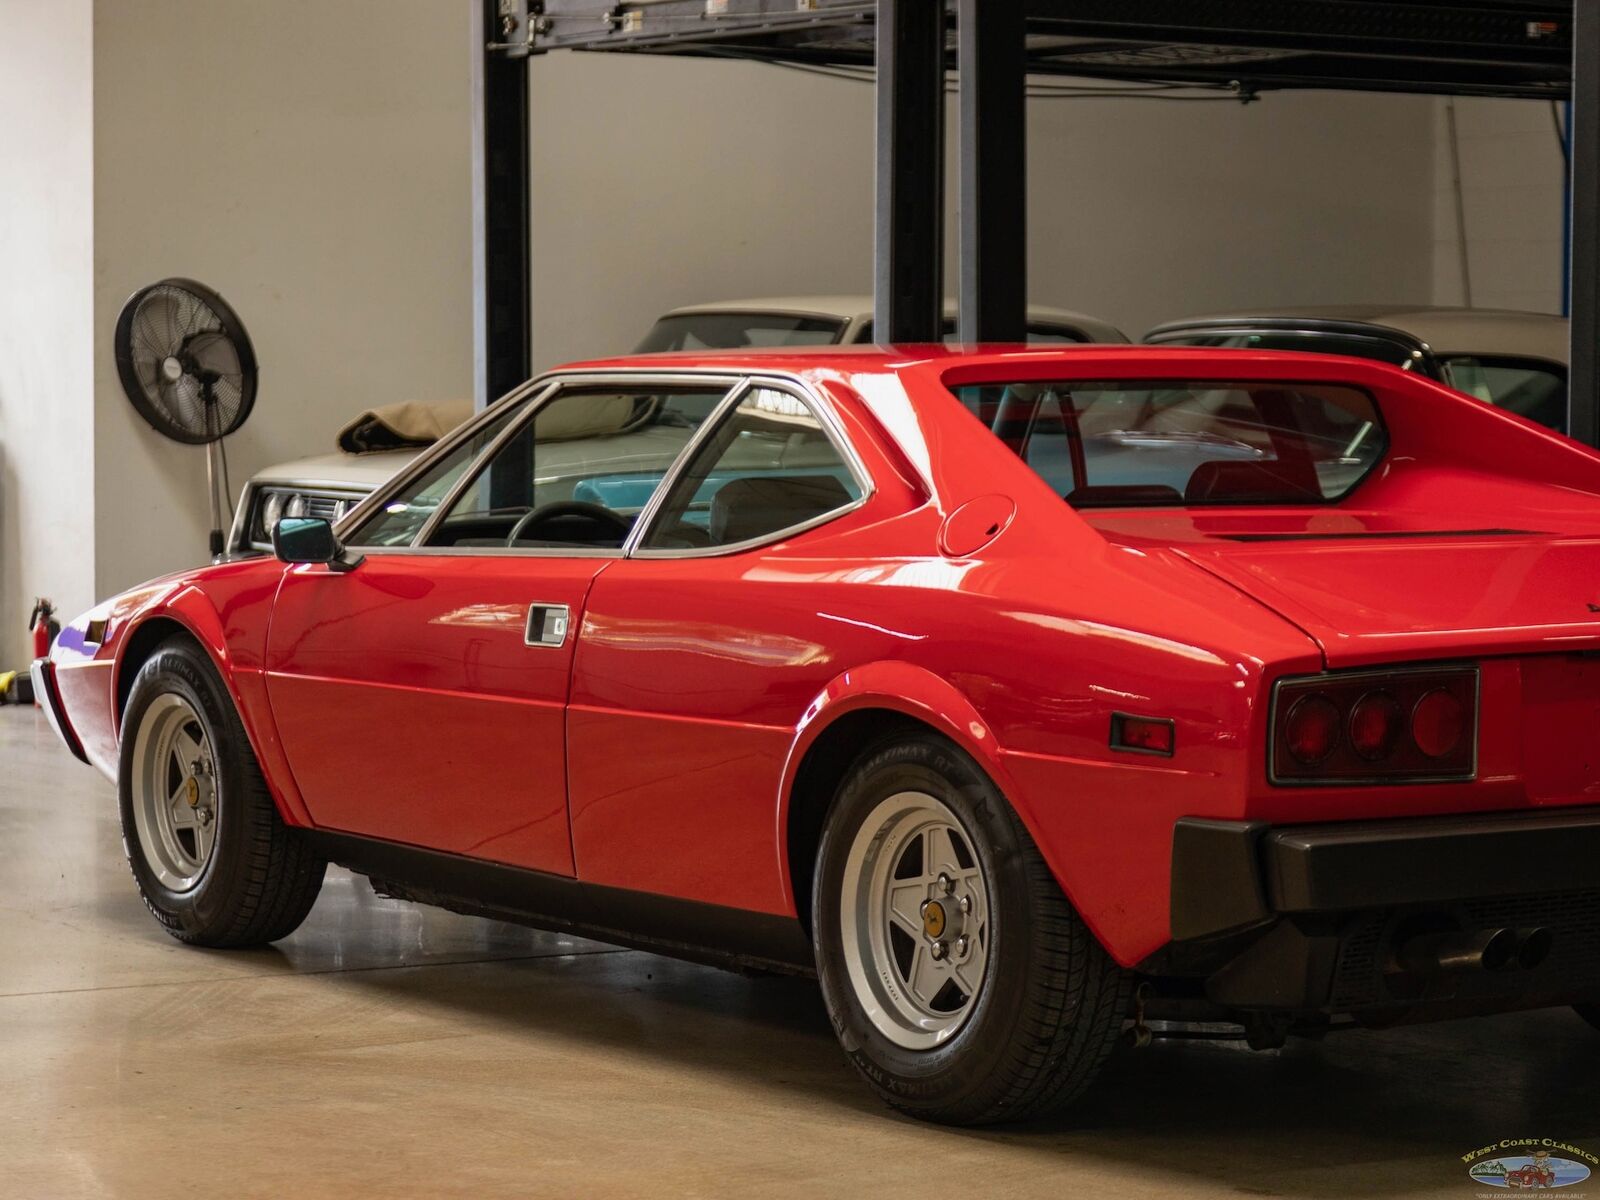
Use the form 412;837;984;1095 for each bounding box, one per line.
1267;808;1600;912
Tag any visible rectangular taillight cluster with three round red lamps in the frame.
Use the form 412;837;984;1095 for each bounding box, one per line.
1270;667;1478;784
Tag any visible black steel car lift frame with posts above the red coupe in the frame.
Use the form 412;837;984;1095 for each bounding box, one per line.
477;0;1600;445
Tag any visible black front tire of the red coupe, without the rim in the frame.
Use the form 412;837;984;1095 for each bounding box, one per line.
117;637;328;947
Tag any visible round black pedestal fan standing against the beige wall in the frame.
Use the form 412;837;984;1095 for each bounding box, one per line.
115;278;256;557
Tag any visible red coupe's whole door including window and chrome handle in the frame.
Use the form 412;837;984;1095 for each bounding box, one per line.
267;379;728;875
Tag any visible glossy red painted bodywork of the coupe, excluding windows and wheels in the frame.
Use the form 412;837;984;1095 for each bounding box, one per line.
54;347;1600;965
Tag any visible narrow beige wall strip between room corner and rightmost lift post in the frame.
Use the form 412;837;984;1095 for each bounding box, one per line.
1434;98;1563;312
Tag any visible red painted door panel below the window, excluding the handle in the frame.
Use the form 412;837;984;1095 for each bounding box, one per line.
266;554;606;875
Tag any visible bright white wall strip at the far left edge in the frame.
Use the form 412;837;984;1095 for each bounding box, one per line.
0;0;94;670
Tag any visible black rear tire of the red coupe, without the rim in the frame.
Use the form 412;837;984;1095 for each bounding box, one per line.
811;734;1133;1125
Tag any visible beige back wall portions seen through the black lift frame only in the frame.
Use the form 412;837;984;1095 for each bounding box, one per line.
531;54;1434;366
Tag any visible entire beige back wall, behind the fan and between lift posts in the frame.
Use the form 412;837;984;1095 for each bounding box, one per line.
12;11;1434;620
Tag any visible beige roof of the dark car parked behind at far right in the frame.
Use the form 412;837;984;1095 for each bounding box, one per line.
1146;304;1568;363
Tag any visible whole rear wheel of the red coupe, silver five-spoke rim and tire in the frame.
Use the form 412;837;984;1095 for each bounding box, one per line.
811;734;1131;1125
